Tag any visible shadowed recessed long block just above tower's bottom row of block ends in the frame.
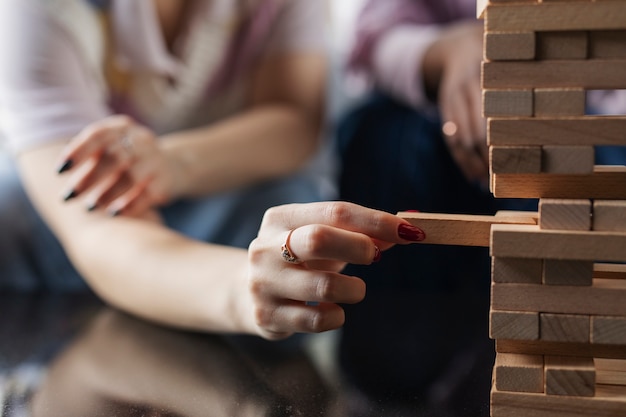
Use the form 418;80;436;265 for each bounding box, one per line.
496;339;626;359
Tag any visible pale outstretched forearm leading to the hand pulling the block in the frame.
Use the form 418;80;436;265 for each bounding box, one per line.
19;143;254;332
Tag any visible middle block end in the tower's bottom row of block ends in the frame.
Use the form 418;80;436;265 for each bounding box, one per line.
544;356;596;397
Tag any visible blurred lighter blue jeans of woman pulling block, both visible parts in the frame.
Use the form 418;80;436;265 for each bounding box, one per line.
0;151;321;292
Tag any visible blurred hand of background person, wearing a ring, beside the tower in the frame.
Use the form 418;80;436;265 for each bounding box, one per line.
426;21;489;184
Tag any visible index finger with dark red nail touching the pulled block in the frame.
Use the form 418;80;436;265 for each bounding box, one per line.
263;201;425;244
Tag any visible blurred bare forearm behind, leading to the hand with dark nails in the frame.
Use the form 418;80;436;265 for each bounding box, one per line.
161;103;321;198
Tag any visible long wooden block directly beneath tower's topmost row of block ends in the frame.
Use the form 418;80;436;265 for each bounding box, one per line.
482;59;626;90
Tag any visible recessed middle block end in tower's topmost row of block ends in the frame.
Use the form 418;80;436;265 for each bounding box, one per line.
537;30;588;59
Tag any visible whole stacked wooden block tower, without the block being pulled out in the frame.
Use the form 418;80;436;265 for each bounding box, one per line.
479;0;626;417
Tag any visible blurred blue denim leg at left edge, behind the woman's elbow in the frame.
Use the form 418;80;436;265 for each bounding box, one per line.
0;151;87;291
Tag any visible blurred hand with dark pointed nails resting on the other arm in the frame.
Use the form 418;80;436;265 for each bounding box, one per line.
58;116;177;216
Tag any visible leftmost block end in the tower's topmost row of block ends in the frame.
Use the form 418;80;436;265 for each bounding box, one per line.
484;31;536;61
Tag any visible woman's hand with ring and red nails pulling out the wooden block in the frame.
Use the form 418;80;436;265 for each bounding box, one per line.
248;202;425;339
